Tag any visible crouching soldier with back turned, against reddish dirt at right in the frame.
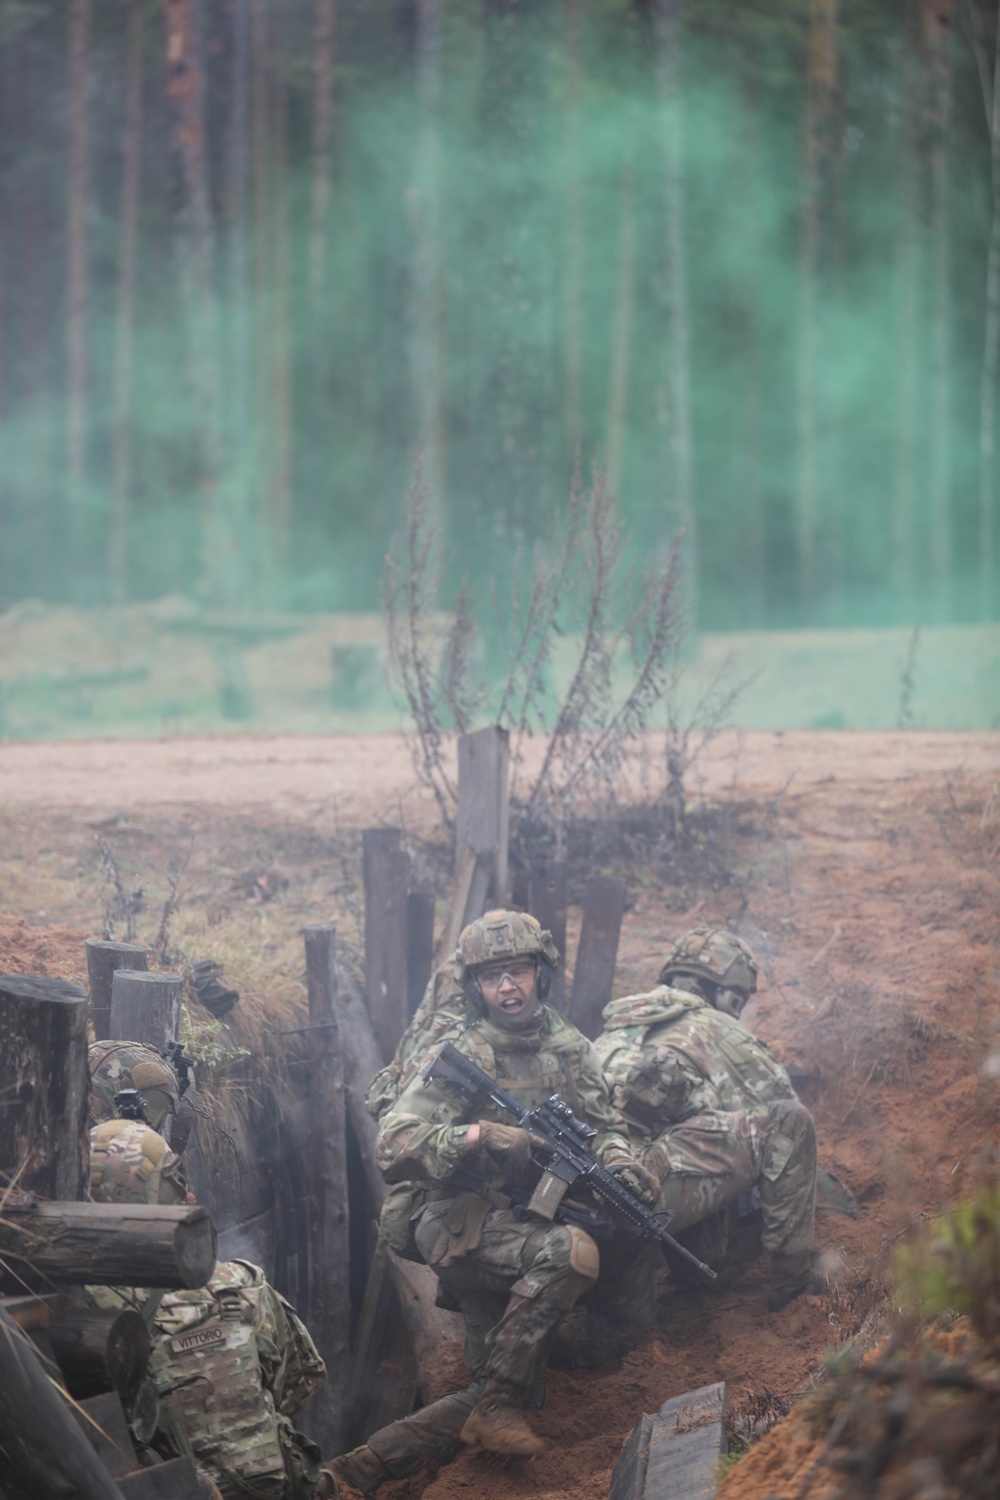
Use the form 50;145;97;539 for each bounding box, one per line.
595;927;819;1311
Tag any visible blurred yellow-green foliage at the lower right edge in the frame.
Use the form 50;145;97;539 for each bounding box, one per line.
897;1185;1000;1349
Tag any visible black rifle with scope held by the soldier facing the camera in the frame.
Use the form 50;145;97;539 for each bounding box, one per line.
424;1041;715;1281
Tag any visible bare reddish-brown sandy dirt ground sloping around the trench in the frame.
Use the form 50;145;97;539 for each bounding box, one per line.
0;734;1000;1500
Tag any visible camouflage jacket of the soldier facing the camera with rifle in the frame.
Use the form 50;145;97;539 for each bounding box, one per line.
375;1005;631;1191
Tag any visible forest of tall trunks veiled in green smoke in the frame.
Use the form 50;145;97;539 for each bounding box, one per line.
0;0;1000;734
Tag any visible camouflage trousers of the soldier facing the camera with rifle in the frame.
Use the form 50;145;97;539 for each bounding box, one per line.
415;1199;600;1404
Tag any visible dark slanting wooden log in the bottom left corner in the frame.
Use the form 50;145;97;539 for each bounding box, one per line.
0;1304;120;1500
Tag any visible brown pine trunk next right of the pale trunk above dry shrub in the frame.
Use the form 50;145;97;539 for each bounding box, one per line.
798;0;838;611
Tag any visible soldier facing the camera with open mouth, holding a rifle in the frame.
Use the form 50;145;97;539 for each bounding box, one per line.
367;911;655;1455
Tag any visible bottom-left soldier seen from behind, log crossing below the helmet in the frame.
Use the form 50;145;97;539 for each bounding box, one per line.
87;1119;325;1500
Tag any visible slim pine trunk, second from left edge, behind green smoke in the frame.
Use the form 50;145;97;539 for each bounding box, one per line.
108;0;142;605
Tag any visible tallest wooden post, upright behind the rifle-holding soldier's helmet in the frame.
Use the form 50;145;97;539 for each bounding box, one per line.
454;725;510;926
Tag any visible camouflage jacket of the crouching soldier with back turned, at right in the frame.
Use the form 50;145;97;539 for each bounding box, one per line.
594;984;796;1134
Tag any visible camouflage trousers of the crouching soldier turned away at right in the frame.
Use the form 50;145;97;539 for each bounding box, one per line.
640;1100;816;1256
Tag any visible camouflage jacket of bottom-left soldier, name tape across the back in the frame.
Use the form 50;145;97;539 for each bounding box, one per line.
87;1260;325;1500
